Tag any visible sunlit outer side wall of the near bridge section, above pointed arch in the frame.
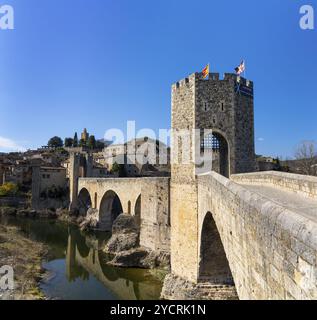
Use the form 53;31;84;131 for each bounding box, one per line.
198;172;317;299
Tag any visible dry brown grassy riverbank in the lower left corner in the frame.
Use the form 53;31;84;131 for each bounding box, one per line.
0;225;48;300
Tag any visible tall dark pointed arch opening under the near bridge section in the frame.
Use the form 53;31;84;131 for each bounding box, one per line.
199;212;234;285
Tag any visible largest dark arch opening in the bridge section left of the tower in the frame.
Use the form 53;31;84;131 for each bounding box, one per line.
99;190;123;231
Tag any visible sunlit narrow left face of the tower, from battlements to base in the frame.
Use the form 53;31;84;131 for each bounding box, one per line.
171;74;198;280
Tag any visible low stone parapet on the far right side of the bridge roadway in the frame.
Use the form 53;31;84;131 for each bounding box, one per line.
230;171;317;198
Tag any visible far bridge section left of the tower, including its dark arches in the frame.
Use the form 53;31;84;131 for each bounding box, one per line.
77;178;170;251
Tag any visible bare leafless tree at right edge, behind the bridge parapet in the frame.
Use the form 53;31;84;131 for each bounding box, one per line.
295;141;317;176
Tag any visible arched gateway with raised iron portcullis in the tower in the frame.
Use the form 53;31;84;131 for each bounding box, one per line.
201;131;230;178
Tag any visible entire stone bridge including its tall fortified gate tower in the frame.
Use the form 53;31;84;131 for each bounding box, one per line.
70;73;317;299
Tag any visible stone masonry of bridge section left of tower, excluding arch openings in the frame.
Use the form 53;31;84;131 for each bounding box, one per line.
78;178;170;251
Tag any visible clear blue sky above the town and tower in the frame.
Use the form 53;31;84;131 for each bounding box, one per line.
0;0;317;157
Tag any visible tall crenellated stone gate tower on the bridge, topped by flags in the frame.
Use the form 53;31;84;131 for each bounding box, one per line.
171;73;255;282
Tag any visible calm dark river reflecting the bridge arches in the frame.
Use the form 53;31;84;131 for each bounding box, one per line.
0;217;162;300
